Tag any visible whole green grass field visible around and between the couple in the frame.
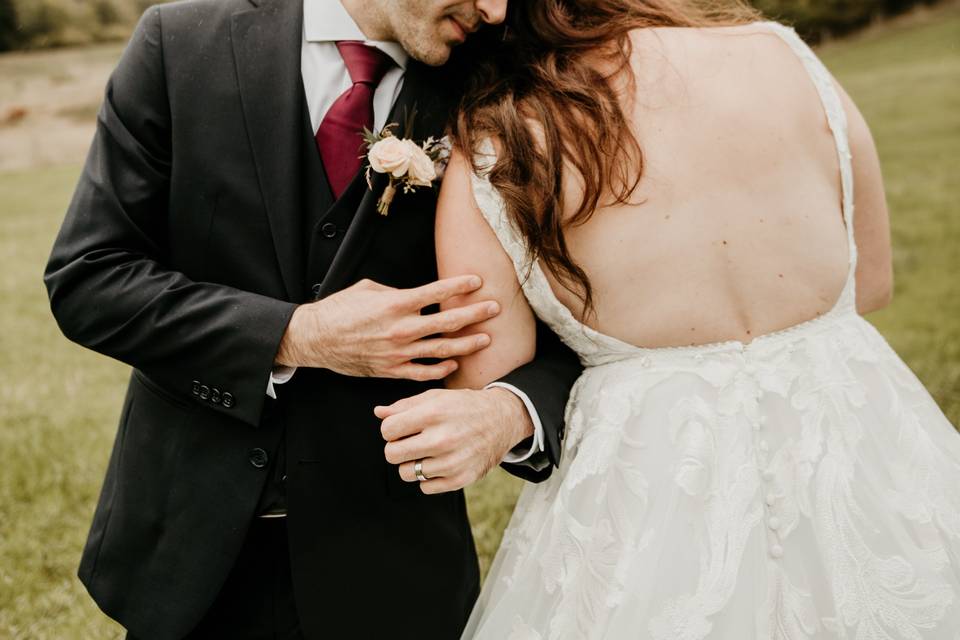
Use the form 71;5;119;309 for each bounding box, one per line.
0;4;960;639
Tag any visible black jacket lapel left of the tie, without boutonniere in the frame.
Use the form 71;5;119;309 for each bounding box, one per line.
231;0;304;300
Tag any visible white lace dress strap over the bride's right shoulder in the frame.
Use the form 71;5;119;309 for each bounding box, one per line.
761;22;857;297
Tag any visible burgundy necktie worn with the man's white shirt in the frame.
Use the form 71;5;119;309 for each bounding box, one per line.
317;40;392;198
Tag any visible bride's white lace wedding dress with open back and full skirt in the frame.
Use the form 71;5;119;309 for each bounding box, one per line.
464;23;960;640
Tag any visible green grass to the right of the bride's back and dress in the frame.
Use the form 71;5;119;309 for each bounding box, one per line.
821;12;960;425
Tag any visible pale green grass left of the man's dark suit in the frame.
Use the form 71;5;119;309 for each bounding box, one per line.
0;166;127;639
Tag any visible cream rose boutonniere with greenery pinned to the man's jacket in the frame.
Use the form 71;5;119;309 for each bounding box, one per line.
363;107;451;216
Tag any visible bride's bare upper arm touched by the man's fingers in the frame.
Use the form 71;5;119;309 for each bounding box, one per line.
436;151;536;389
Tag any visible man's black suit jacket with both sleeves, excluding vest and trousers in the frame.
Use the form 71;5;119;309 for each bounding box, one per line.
45;0;580;640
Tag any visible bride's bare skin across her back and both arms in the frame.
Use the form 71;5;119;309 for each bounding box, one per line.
437;24;891;386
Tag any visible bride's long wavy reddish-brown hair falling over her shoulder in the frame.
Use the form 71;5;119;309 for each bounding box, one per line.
452;0;758;315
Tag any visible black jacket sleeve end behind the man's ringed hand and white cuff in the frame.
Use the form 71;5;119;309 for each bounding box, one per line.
498;321;583;482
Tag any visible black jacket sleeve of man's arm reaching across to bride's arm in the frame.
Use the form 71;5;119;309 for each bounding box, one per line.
44;8;296;426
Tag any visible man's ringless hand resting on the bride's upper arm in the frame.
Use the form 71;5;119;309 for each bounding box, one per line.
276;276;500;381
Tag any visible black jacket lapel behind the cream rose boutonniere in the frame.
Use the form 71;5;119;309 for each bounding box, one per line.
316;60;446;298
